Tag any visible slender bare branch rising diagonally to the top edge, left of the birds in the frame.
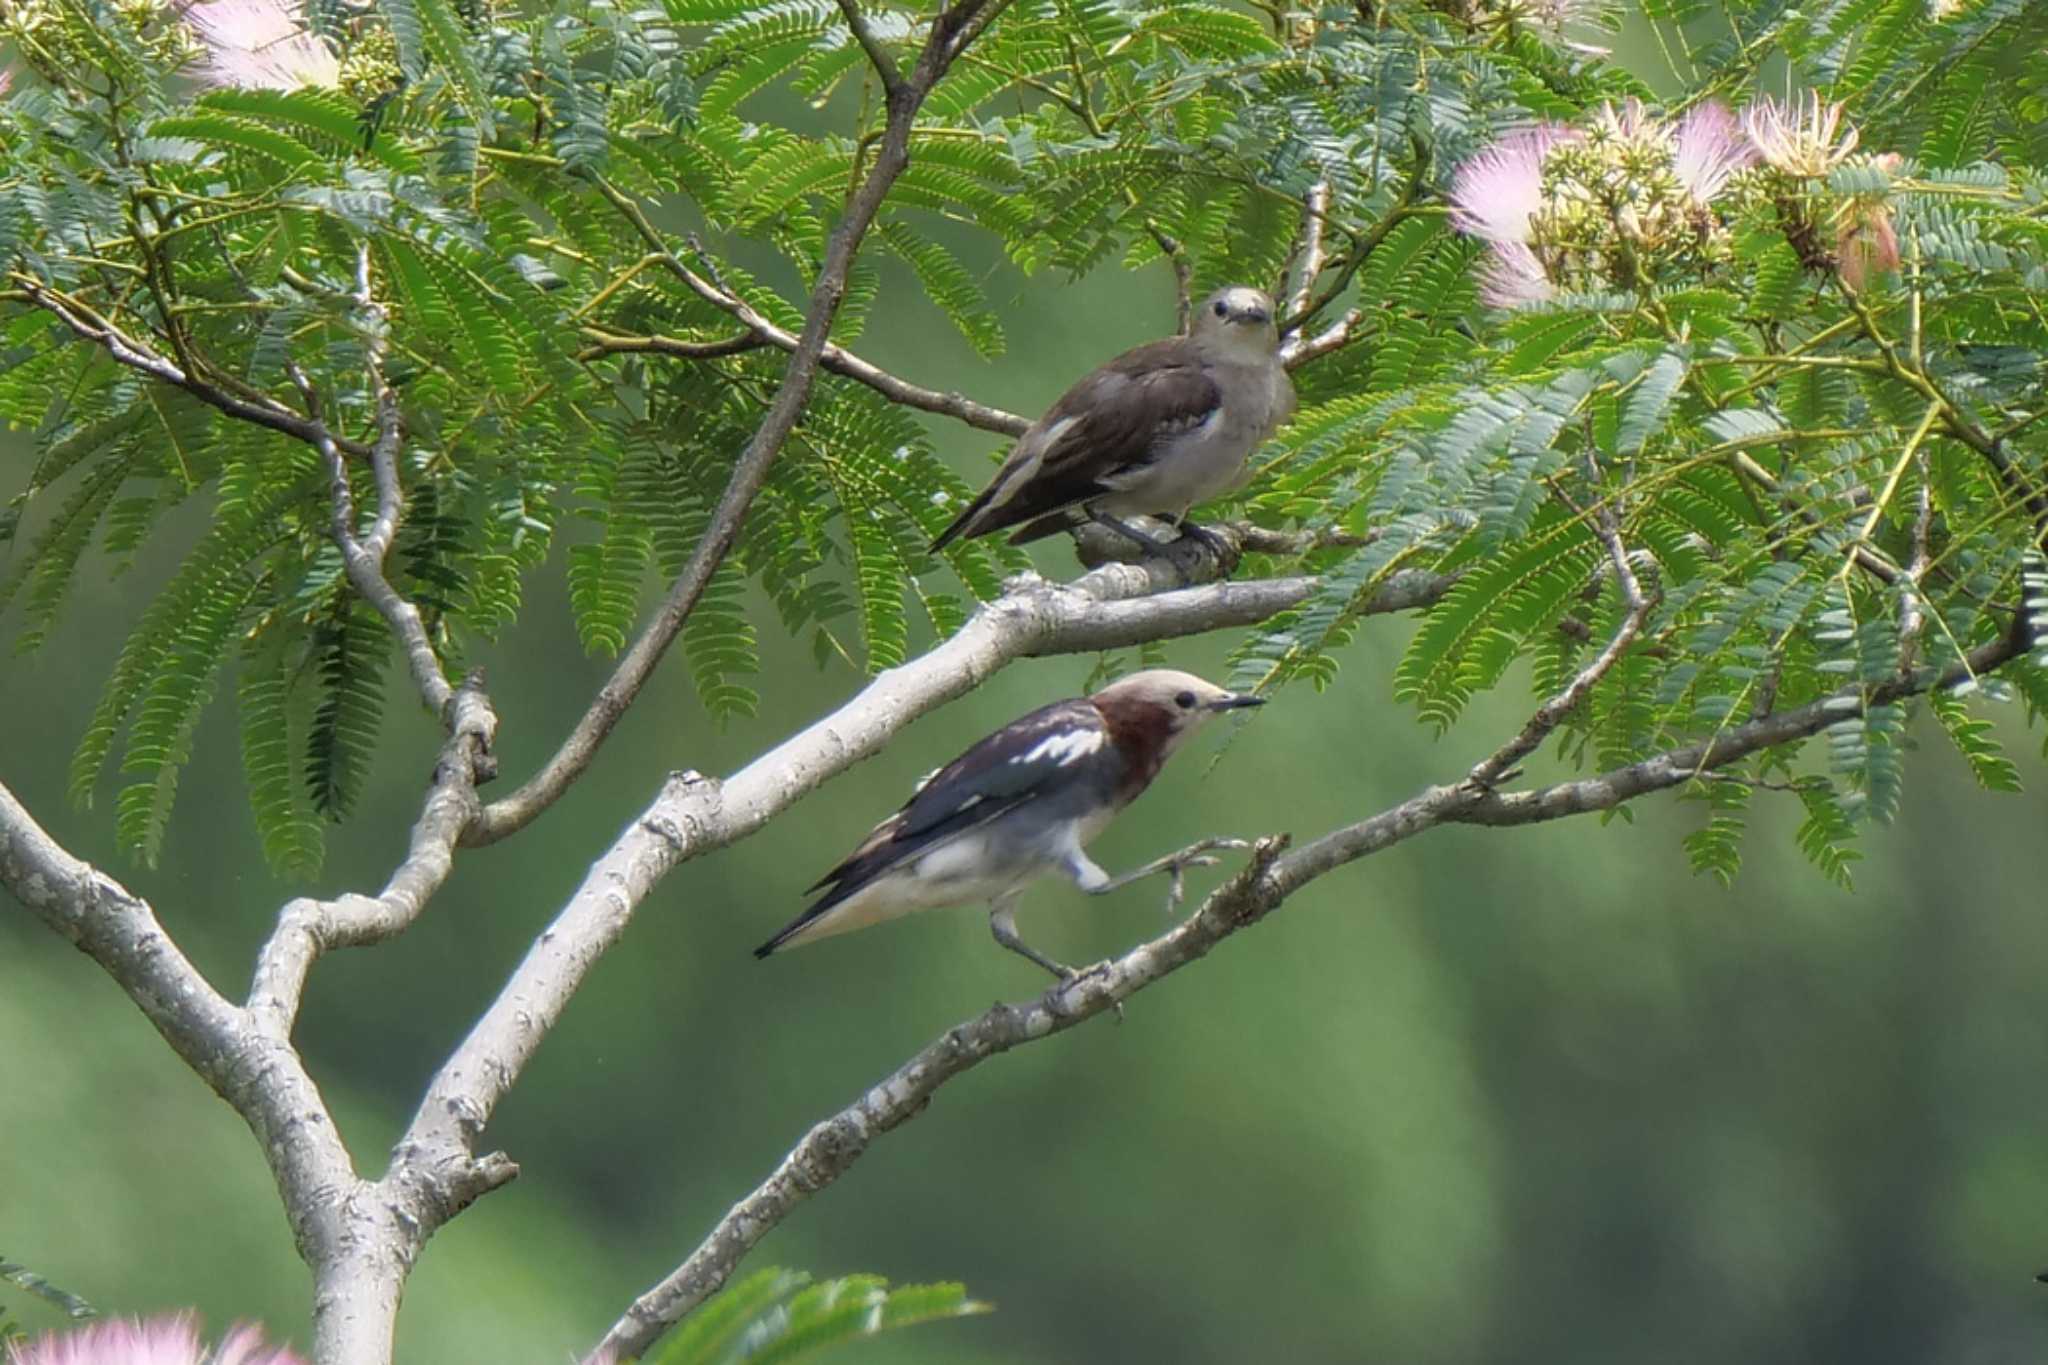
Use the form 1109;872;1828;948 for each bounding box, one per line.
467;0;1024;843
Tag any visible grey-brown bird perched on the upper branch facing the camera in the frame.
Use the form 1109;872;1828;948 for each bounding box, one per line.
932;284;1294;553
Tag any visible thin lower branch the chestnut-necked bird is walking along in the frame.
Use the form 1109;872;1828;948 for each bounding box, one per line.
586;597;2019;1365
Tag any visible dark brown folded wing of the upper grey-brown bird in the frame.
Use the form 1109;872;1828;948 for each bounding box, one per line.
934;336;1223;548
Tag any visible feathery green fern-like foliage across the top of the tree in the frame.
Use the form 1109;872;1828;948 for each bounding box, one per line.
0;0;2048;878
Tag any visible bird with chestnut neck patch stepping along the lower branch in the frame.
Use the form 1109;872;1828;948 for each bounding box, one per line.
754;669;1266;980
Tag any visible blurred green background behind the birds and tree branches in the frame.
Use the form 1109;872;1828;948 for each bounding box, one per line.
12;61;2048;1365
